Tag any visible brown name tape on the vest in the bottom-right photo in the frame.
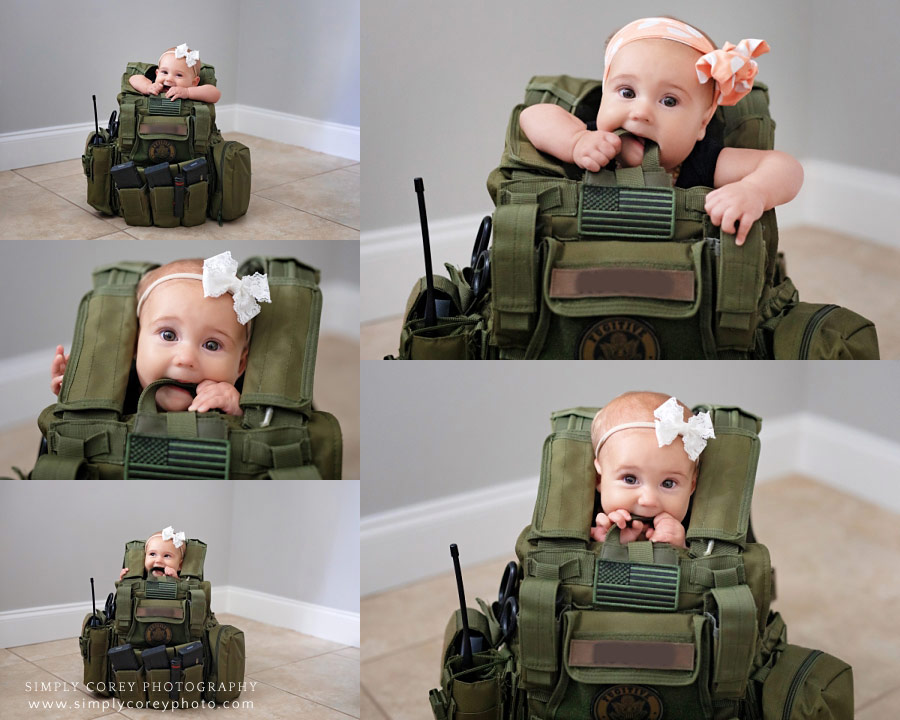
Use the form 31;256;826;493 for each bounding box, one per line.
569;640;694;670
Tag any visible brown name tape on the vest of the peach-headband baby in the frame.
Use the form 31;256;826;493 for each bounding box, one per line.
550;267;695;302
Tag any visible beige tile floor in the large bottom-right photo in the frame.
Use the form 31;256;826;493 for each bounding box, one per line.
361;476;900;720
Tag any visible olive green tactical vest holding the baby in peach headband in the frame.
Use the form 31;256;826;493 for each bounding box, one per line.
399;75;878;360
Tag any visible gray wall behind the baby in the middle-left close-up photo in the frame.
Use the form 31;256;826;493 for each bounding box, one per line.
0;240;359;367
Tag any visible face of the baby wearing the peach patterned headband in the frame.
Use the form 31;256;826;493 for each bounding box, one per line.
597;39;715;172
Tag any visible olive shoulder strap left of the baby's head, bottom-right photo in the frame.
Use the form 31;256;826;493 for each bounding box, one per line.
529;430;596;543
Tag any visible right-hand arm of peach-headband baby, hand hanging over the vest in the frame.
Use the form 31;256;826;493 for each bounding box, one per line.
706;148;803;245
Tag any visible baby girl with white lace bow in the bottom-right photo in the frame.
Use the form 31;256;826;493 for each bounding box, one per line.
591;392;715;547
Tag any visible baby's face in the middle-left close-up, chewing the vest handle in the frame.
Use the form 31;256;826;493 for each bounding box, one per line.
136;279;248;411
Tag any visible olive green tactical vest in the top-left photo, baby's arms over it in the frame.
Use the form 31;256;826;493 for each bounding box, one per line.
82;62;250;227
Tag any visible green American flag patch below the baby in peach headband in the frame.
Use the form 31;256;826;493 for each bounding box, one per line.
578;183;675;240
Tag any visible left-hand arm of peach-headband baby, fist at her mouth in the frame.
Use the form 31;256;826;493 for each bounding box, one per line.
519;103;622;172
